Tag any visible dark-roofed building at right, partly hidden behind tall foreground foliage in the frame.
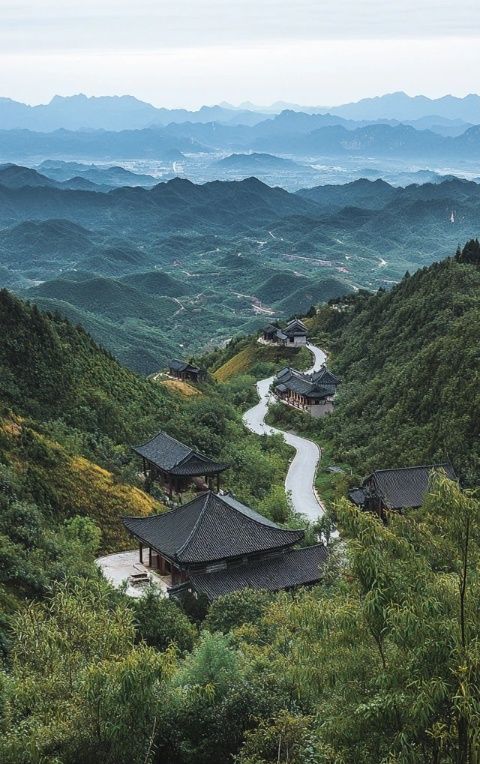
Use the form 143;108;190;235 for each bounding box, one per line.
348;463;457;519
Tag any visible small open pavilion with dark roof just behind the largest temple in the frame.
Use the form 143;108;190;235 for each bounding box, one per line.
133;432;229;496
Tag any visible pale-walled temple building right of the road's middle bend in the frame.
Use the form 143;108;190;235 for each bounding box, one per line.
273;366;340;417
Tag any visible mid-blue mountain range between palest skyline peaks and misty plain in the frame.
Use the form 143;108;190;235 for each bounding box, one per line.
0;120;480;164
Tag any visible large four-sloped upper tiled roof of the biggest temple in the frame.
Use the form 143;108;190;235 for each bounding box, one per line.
123;491;304;564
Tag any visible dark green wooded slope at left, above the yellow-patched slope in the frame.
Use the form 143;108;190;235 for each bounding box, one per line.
0;290;169;442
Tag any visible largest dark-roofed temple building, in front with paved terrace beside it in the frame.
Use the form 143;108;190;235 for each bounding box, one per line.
123;491;328;600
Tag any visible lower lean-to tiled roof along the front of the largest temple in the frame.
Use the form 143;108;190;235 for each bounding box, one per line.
190;544;328;600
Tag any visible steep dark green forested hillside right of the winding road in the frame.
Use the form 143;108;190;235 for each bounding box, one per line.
314;242;480;484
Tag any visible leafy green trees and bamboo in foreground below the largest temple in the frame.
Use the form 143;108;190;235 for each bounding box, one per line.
0;476;480;764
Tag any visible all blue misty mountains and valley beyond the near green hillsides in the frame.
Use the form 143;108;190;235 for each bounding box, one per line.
0;93;480;373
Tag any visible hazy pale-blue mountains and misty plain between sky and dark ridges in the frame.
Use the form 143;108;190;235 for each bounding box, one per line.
0;93;480;191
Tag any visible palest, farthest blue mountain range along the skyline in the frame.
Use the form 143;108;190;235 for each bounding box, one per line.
0;92;480;132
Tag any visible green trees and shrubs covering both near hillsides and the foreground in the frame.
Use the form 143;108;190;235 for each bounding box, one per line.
0;244;480;764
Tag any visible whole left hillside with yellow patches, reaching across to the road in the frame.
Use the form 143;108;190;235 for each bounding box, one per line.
0;290;300;640
